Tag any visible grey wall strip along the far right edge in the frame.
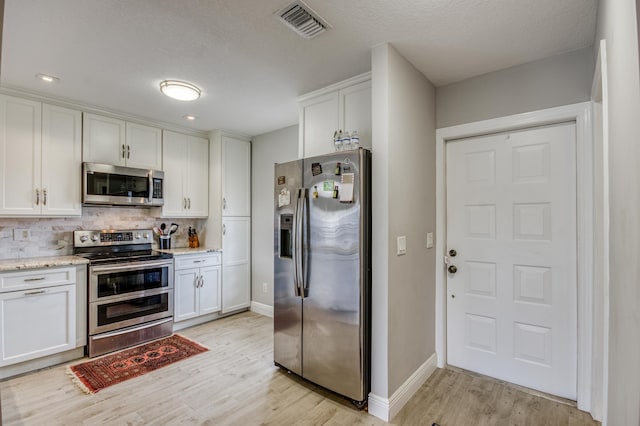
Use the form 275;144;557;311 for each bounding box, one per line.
596;0;640;426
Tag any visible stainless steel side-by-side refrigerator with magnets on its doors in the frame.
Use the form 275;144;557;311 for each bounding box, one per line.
274;148;371;407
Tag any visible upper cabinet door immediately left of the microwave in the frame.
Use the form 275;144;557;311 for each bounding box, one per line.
41;104;82;216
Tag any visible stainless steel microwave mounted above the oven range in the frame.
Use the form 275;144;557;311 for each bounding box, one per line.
82;163;164;207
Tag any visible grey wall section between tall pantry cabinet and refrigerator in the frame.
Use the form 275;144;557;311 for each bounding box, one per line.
251;125;298;306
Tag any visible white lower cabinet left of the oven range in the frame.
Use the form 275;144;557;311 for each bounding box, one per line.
0;267;77;366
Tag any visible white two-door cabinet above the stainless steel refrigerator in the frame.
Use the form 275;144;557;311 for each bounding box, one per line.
298;73;371;158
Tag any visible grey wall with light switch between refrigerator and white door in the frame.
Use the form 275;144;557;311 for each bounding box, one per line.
372;44;435;398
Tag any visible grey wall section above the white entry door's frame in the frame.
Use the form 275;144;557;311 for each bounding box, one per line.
436;48;595;128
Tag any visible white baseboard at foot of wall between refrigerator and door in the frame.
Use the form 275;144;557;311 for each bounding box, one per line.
369;353;436;422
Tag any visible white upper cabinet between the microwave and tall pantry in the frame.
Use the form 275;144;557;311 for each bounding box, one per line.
162;130;209;217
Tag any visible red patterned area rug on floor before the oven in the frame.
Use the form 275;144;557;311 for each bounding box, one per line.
67;334;209;393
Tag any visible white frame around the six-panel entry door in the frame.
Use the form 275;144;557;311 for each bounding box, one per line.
435;102;594;411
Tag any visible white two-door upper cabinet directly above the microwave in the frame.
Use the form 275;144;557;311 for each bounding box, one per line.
82;113;162;170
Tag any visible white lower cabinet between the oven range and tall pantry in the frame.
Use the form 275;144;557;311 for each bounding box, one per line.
173;253;222;322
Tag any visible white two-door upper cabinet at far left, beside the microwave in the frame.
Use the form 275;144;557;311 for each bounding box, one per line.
0;95;82;216
